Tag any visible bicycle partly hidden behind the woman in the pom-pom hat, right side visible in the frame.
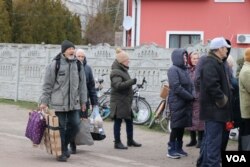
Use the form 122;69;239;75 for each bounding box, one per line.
132;77;152;125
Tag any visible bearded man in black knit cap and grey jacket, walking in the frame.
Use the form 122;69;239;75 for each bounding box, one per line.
40;40;87;162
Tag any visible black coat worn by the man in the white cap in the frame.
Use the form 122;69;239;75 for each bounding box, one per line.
200;52;232;122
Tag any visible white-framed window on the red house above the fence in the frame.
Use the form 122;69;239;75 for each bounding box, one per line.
166;31;203;48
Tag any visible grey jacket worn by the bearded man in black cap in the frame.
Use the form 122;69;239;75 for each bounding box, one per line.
40;55;87;111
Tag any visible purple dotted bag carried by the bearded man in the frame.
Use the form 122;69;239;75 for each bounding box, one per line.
25;111;46;144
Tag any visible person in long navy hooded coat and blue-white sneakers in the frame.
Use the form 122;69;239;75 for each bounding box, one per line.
167;49;194;159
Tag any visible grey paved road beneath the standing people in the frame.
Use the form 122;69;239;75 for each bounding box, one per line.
0;104;236;167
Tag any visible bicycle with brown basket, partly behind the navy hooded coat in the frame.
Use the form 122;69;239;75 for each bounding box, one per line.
148;79;171;133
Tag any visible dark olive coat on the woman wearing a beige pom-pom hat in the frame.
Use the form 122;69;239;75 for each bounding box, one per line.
110;60;135;119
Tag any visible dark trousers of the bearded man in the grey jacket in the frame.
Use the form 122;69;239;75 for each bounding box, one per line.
55;110;80;153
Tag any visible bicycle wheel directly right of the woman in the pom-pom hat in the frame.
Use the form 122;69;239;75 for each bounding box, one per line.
132;97;151;125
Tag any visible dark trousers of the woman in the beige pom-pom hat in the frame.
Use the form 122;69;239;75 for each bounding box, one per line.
114;118;133;142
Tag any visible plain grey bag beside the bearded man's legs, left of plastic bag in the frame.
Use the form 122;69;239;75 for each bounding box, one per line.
75;119;94;146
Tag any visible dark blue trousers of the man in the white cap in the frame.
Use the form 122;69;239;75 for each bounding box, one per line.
197;121;225;167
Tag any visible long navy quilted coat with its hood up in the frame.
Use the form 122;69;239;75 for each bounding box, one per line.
168;49;195;128
